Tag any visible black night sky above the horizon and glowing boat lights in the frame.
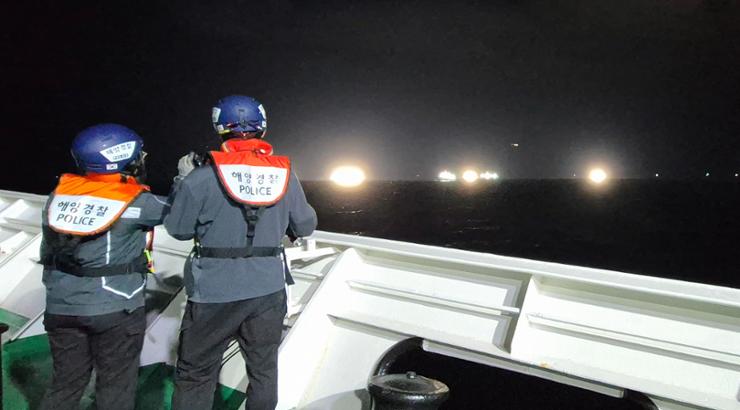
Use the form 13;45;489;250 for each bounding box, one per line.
0;0;740;193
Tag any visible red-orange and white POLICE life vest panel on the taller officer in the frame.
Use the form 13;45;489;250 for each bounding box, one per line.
210;139;290;207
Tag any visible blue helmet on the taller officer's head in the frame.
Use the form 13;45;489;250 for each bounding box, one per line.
212;95;267;138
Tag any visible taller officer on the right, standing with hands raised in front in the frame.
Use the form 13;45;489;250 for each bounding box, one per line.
164;95;316;410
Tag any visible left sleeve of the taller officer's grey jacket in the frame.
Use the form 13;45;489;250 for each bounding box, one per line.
164;178;201;241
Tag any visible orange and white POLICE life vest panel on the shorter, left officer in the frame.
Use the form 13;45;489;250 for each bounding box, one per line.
47;174;149;236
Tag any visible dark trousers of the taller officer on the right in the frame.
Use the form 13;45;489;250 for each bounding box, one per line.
172;290;287;410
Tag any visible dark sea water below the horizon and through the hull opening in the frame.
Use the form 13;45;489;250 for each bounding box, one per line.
304;180;740;410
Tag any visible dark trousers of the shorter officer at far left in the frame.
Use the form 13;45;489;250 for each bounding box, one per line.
41;307;146;410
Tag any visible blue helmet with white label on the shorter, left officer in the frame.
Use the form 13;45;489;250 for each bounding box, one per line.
71;124;144;174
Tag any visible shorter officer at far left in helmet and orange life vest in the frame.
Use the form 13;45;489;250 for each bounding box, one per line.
41;124;167;410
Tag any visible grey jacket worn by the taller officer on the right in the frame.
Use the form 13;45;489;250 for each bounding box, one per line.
164;166;317;303
